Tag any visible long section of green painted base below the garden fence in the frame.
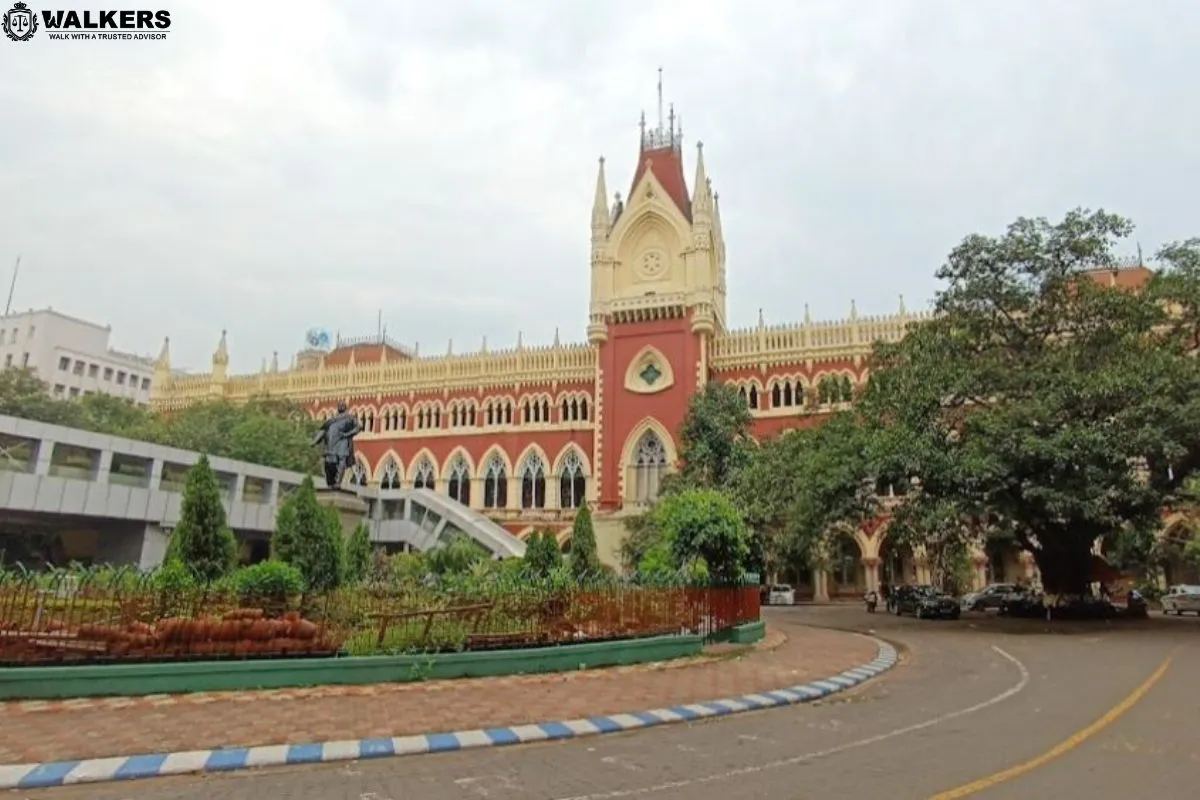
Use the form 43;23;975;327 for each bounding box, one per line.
0;636;703;700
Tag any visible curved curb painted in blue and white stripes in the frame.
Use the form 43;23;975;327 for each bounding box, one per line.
0;639;898;789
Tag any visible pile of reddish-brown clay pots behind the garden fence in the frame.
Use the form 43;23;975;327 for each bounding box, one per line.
78;608;337;657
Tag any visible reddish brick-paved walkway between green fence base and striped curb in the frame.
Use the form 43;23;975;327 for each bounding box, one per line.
0;625;876;764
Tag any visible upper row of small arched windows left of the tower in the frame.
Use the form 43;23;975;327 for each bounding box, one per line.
333;395;590;433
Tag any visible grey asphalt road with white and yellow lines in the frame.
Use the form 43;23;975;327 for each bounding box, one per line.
8;606;1200;800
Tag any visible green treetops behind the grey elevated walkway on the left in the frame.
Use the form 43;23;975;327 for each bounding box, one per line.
0;368;320;474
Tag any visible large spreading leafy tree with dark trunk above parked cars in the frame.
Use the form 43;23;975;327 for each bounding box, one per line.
863;210;1200;594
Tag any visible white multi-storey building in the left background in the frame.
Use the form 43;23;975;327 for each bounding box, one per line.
0;308;155;405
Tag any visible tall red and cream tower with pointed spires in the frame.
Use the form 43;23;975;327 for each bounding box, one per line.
588;84;725;510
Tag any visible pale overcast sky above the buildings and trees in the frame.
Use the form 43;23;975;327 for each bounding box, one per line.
0;0;1200;372
